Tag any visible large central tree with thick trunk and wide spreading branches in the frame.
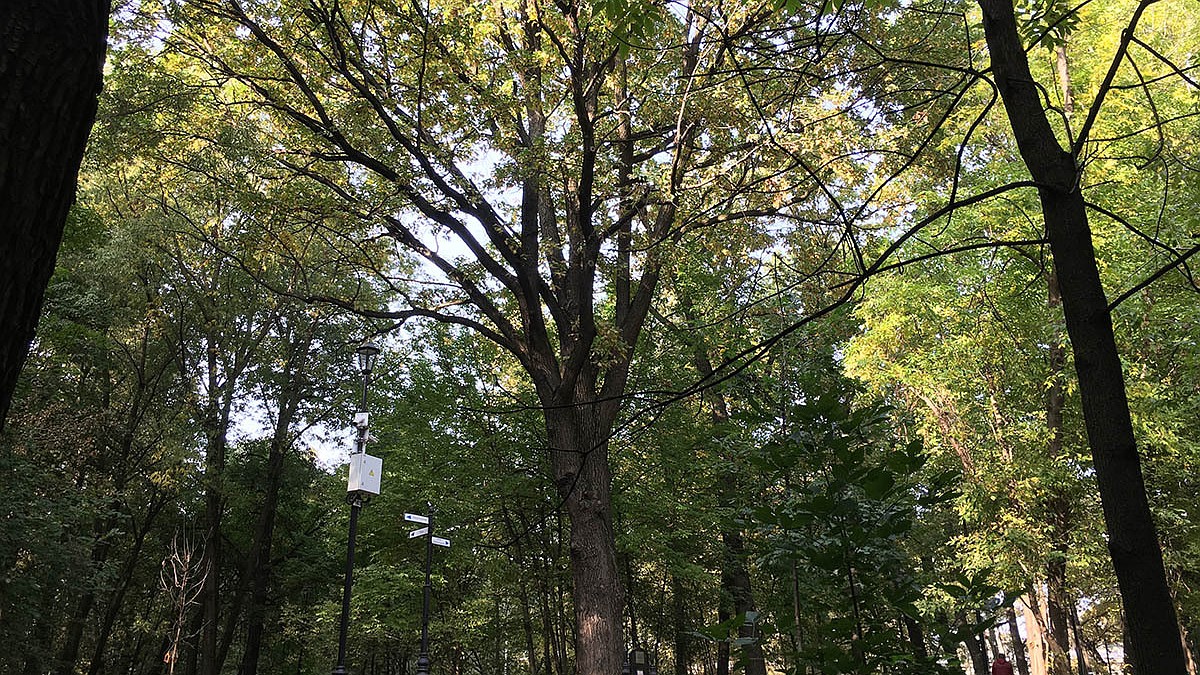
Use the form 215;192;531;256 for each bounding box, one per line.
162;0;835;675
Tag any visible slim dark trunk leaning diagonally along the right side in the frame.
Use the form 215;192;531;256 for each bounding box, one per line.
979;0;1186;675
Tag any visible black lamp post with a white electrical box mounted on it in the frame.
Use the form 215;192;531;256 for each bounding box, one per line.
332;342;383;675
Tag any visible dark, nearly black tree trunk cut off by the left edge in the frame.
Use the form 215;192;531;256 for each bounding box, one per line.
0;0;109;429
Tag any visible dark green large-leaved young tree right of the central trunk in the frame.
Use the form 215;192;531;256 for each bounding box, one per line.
750;395;974;674
